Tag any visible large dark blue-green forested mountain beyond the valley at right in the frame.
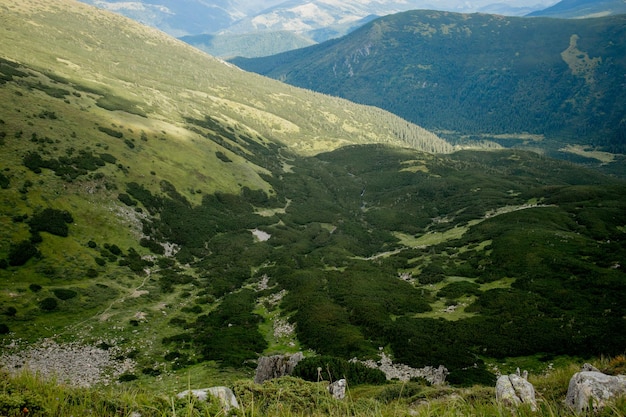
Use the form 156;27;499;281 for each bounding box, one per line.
233;11;626;161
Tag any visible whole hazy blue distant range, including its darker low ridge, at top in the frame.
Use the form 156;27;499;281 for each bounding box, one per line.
82;0;555;57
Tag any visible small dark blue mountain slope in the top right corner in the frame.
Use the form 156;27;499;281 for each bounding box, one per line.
528;0;626;18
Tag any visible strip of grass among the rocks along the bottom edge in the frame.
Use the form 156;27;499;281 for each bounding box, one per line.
0;366;626;417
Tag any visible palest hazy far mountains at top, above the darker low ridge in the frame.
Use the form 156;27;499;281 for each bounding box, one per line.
80;0;557;37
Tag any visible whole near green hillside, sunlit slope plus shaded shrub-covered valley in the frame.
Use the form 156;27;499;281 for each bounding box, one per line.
0;0;626;392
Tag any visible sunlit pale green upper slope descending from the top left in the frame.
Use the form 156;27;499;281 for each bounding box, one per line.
0;0;450;157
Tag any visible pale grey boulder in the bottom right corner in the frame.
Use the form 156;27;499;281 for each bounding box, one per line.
565;371;626;413
